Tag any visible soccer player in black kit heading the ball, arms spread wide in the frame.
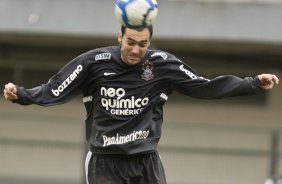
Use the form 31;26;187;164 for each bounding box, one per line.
4;26;279;184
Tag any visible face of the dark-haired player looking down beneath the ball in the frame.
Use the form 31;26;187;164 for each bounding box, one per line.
118;28;150;65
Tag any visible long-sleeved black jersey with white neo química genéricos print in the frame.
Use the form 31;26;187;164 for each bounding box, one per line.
12;46;260;154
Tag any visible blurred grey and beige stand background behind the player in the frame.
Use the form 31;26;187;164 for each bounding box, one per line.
0;0;282;184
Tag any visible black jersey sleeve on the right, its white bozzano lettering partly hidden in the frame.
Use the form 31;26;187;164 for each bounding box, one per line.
166;60;260;99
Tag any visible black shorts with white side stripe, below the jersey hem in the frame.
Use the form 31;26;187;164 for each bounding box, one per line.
85;151;166;184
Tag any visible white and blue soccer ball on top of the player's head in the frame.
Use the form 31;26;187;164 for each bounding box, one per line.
115;0;158;28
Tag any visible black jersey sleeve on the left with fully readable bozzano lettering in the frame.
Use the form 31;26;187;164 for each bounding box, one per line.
13;52;88;106
